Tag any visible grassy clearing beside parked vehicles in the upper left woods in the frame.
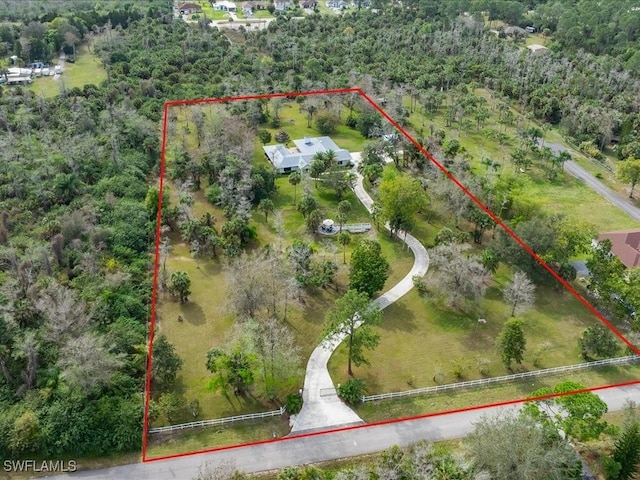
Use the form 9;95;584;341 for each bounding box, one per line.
25;45;107;97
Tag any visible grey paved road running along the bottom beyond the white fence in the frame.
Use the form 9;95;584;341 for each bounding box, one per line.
54;385;640;480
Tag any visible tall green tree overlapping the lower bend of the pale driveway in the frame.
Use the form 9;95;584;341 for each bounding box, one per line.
323;290;382;375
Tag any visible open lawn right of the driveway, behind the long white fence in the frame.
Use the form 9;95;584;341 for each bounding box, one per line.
329;256;622;394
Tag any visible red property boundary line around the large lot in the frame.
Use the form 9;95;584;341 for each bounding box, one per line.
142;88;640;462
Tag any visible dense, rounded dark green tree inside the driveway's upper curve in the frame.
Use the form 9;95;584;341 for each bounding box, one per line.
349;240;389;298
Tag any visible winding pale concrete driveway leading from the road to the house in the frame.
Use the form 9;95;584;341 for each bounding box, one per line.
291;153;429;434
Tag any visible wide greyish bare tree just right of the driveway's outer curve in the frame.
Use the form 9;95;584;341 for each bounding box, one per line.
429;244;488;309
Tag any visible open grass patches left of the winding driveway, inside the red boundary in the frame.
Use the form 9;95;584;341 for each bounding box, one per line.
156;105;413;425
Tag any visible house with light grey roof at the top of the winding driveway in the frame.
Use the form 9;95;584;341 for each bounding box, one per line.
262;137;351;173
